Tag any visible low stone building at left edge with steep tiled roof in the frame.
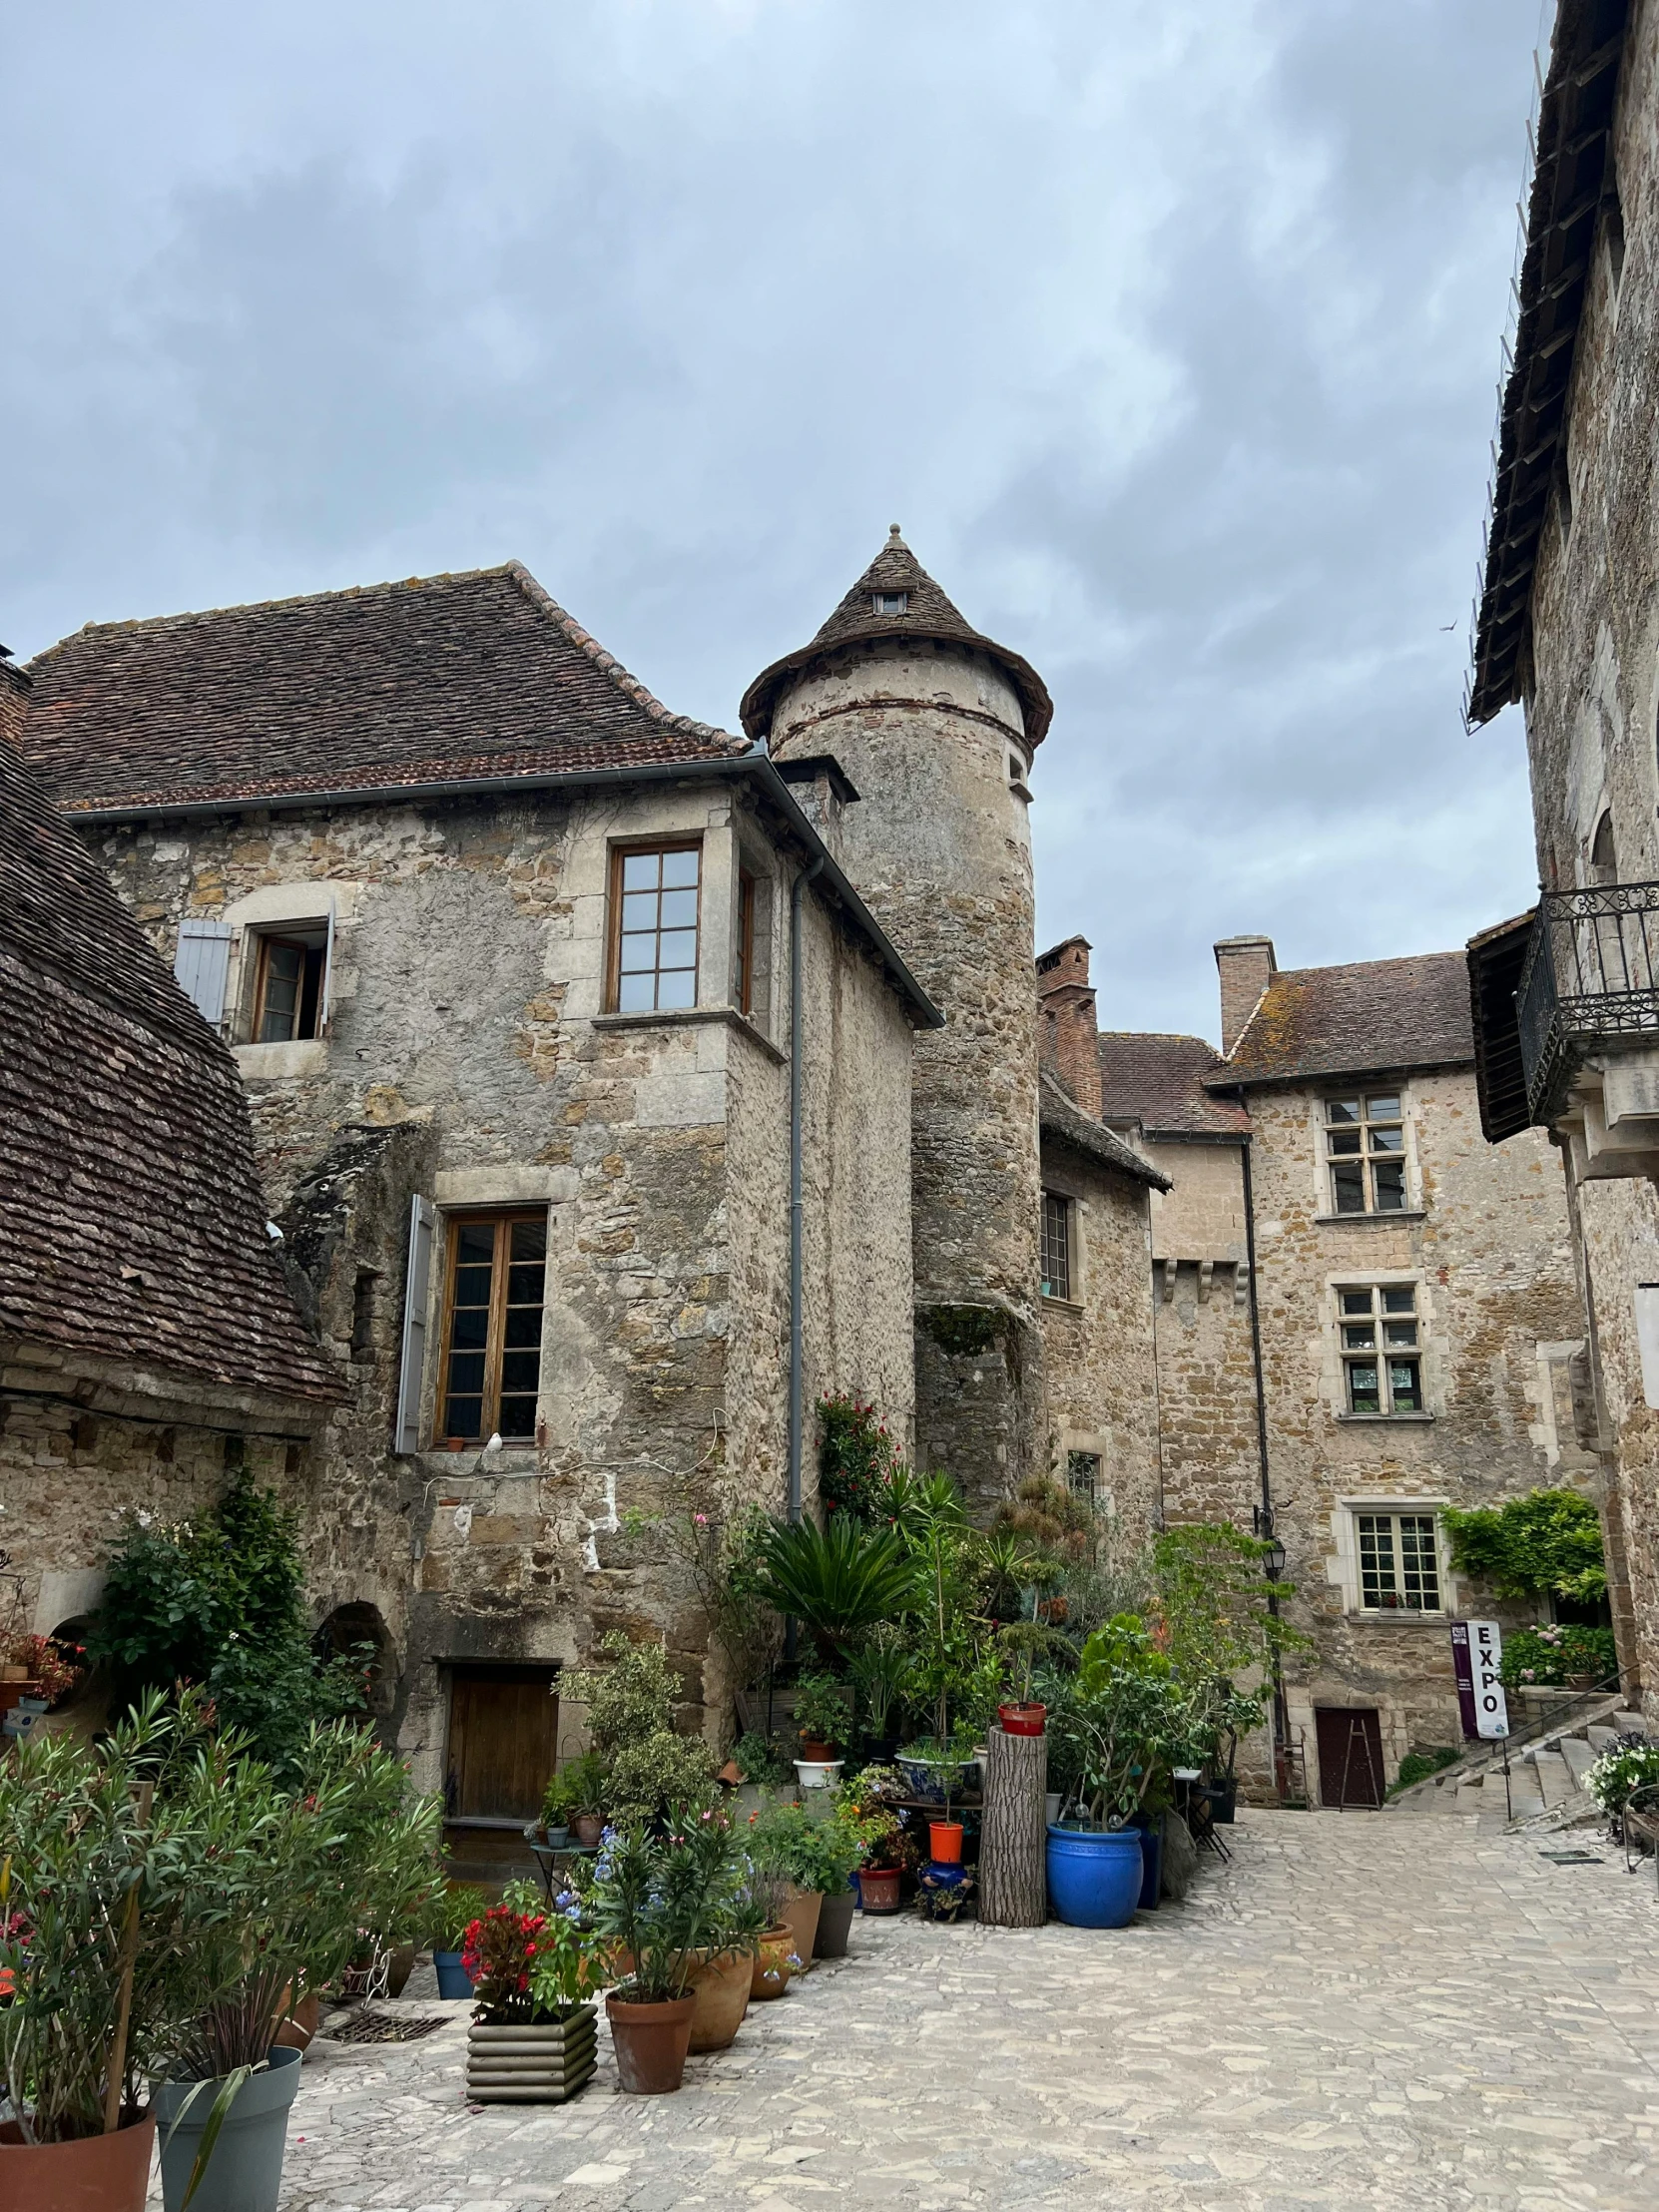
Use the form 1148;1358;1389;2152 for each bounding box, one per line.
0;659;340;1663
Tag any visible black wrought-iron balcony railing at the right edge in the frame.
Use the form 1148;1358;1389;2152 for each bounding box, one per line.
1515;882;1659;1124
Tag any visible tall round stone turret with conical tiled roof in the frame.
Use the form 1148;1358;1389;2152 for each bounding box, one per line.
744;524;1053;1502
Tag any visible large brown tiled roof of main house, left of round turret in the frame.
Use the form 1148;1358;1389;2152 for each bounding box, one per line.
24;562;744;812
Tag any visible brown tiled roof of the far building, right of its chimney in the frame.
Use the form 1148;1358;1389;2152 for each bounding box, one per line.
1212;953;1475;1084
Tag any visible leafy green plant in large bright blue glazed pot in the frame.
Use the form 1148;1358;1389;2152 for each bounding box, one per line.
1048;1612;1190;1927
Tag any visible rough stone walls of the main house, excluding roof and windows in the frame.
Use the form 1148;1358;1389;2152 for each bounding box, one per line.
89;779;911;1781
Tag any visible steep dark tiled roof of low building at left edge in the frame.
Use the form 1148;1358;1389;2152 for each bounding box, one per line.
0;668;338;1398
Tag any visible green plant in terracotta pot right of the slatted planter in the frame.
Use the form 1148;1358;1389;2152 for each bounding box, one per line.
593;1812;732;2097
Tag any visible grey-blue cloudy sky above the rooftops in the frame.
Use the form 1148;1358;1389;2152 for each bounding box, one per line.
0;0;1539;1033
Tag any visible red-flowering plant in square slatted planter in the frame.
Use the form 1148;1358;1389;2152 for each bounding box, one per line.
464;1883;604;2103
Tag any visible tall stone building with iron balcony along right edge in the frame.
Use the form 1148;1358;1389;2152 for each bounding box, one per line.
1468;0;1659;1714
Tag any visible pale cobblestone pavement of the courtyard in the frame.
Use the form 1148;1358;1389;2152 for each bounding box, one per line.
253;1812;1659;2212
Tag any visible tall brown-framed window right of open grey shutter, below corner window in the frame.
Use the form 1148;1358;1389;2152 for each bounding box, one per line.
438;1212;546;1442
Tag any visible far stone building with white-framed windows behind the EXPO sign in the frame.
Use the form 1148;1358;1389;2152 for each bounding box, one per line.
1097;935;1597;1803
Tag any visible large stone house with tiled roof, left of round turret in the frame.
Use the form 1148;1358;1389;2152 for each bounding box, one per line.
16;564;940;1843
